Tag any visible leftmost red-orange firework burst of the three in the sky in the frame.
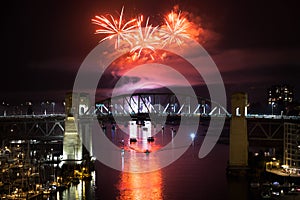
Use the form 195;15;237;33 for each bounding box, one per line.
92;7;137;49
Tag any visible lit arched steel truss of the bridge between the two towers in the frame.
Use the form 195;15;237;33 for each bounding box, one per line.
92;93;230;116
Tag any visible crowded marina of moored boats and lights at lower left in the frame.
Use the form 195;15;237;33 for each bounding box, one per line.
0;141;95;199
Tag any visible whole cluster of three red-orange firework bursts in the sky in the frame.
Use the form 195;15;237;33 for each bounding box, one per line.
92;7;197;60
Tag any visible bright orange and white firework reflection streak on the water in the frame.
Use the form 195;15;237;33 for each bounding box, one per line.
117;122;163;200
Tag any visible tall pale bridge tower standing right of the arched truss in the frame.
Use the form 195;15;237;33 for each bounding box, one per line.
228;93;248;175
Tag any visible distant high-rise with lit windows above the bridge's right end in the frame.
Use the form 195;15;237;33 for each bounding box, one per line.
268;85;294;105
